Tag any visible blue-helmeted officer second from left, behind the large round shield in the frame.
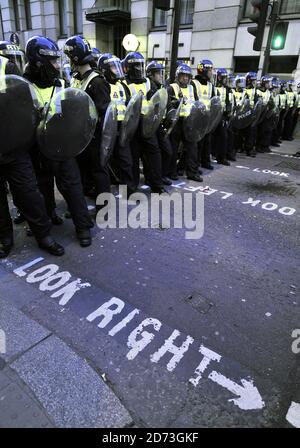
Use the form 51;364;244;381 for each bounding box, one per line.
24;36;93;247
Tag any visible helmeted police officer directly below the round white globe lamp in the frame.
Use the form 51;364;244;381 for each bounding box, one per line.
98;53;136;196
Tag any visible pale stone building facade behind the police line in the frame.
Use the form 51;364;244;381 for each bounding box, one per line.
0;0;300;79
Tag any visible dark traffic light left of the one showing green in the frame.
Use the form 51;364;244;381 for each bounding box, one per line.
247;0;269;51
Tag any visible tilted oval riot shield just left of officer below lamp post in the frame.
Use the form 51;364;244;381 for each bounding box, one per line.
142;88;168;138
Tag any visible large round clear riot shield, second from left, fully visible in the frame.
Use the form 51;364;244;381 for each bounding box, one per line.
37;88;98;161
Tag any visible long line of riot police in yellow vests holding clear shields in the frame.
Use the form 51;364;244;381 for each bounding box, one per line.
0;36;299;257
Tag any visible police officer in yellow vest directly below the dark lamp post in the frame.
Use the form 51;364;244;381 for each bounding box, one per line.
168;64;203;182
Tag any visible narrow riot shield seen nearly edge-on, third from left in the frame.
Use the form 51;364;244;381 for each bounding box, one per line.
100;102;118;166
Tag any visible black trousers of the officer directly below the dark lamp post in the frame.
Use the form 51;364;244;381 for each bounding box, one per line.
170;118;198;176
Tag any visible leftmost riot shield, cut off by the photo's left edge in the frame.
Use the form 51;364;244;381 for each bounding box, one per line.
0;75;43;157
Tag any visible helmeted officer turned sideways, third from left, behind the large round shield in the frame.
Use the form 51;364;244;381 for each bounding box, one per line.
64;36;111;201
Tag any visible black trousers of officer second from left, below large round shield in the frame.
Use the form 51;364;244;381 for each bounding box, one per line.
31;152;93;231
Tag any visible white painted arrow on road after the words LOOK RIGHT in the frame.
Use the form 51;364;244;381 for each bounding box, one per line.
208;371;265;411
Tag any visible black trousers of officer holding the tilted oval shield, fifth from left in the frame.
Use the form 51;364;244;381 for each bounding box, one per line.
130;124;163;189
